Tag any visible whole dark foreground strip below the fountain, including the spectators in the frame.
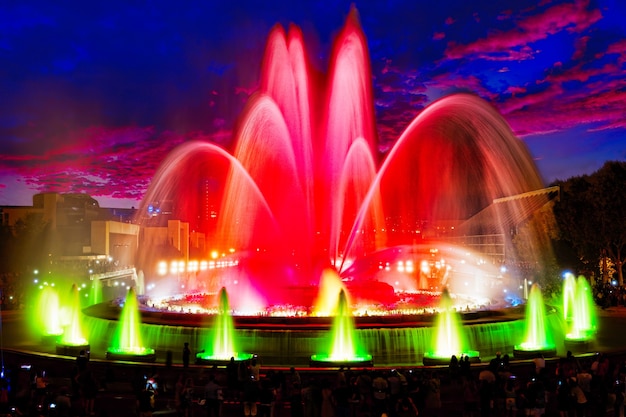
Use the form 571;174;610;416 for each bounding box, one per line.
6;309;626;417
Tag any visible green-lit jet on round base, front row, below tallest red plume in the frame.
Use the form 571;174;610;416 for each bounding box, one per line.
311;289;372;367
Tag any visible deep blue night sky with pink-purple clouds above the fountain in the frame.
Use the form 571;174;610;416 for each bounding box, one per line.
0;0;626;207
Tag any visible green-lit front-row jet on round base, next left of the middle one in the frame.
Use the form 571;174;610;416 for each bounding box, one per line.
196;287;254;365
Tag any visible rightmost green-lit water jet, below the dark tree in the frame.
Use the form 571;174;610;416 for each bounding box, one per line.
563;274;597;352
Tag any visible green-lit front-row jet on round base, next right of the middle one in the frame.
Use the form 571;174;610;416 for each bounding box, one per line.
423;290;480;365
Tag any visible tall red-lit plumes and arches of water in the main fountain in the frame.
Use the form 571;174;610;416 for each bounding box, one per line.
134;10;543;304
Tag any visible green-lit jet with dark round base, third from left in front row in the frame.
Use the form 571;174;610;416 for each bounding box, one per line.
106;288;156;362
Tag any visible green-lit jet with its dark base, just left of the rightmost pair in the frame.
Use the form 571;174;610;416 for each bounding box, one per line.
513;284;556;359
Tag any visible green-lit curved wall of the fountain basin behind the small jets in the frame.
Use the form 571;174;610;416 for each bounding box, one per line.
79;314;565;366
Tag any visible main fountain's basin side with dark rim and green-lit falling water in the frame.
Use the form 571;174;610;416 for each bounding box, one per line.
84;304;540;366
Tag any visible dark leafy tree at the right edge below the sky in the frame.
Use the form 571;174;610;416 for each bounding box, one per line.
554;161;626;285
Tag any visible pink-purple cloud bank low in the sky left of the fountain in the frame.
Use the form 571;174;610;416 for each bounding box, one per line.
0;127;230;205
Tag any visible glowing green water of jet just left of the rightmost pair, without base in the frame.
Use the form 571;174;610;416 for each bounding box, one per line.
516;284;554;350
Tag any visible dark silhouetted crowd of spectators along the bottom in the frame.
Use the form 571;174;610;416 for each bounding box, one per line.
0;352;626;417
